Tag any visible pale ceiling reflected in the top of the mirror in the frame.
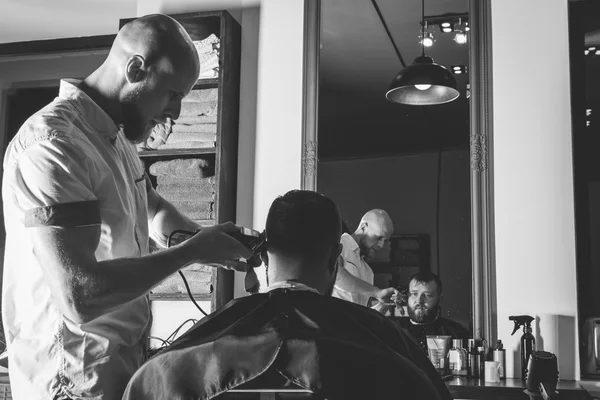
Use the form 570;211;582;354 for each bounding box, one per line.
320;0;469;95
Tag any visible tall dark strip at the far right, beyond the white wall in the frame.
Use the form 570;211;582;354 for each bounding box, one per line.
569;0;600;378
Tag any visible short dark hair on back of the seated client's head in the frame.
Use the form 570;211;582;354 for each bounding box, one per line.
265;190;342;257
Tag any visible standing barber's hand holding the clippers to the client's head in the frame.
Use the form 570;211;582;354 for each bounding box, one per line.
181;222;252;272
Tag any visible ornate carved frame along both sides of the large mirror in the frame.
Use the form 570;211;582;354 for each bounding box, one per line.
301;0;497;344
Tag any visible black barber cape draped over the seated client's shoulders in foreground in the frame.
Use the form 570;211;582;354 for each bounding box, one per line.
123;289;452;400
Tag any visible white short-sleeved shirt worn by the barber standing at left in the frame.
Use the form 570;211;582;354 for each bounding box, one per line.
2;81;151;400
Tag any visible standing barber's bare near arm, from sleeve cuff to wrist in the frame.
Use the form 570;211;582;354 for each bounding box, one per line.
30;226;199;323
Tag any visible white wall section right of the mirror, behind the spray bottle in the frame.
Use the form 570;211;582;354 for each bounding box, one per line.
492;0;579;379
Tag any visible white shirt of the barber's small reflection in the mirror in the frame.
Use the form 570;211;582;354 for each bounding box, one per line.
331;233;374;306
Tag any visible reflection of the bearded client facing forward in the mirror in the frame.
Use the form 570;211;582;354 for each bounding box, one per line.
396;271;469;351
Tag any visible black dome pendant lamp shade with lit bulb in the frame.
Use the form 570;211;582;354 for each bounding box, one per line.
385;56;460;106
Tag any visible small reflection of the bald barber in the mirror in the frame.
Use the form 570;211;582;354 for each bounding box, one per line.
332;209;399;314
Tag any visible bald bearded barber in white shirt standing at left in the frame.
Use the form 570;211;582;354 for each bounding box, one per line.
2;15;251;400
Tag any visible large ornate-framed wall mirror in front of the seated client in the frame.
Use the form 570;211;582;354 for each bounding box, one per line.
303;0;495;343
